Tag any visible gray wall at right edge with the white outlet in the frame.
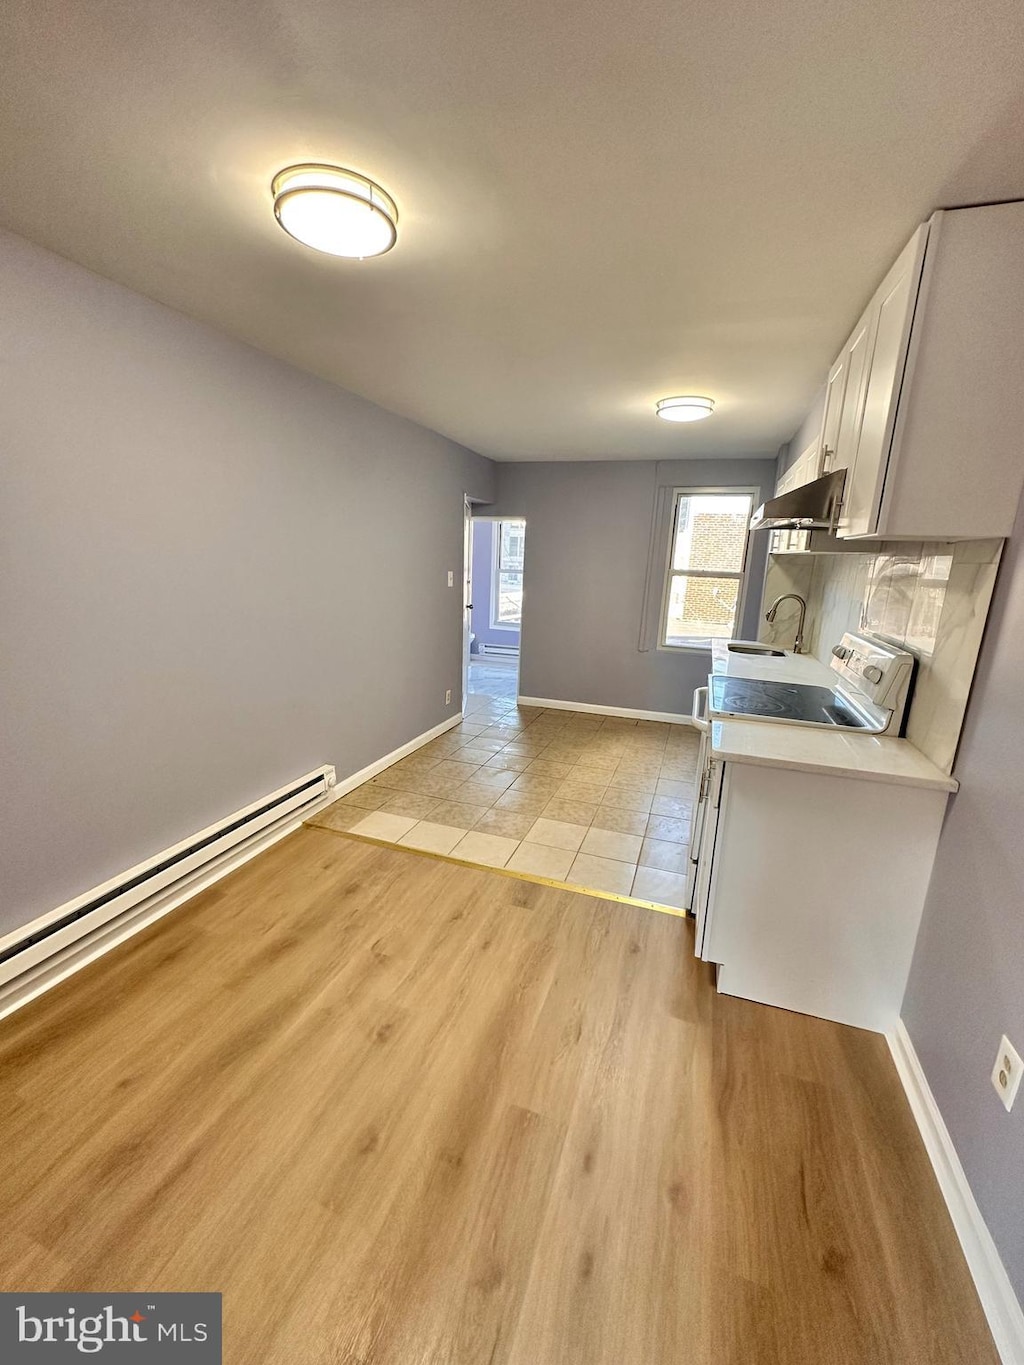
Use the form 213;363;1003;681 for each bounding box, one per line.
902;504;1024;1301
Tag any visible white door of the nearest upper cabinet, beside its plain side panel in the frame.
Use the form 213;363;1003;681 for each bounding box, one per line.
838;224;928;535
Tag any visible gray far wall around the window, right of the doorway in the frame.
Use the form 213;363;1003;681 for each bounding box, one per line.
486;460;776;713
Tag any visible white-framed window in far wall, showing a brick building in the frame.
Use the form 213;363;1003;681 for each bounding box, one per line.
658;489;754;650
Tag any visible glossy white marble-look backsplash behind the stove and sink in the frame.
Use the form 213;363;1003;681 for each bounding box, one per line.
760;541;1002;773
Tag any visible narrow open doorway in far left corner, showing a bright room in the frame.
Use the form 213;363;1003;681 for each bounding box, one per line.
463;509;526;715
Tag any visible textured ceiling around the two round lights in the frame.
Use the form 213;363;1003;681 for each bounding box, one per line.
0;0;1024;459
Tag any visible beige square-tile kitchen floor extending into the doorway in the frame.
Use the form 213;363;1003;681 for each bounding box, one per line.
310;663;696;908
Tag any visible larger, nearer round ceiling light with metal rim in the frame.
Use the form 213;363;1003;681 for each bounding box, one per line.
272;162;399;261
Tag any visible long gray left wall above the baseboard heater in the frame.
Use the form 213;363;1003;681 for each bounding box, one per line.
0;235;493;932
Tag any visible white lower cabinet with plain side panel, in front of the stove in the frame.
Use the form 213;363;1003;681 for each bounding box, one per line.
692;755;948;1033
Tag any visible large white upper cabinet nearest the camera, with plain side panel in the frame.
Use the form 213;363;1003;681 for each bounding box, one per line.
824;203;1024;541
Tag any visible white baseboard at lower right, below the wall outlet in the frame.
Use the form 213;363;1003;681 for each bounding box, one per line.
887;1020;1024;1365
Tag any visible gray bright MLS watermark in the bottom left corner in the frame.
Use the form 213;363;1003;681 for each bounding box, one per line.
0;1293;221;1365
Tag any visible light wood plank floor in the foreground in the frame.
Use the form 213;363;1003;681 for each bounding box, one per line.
0;829;995;1365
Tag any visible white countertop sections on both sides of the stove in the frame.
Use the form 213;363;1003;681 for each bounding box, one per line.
711;640;960;792
